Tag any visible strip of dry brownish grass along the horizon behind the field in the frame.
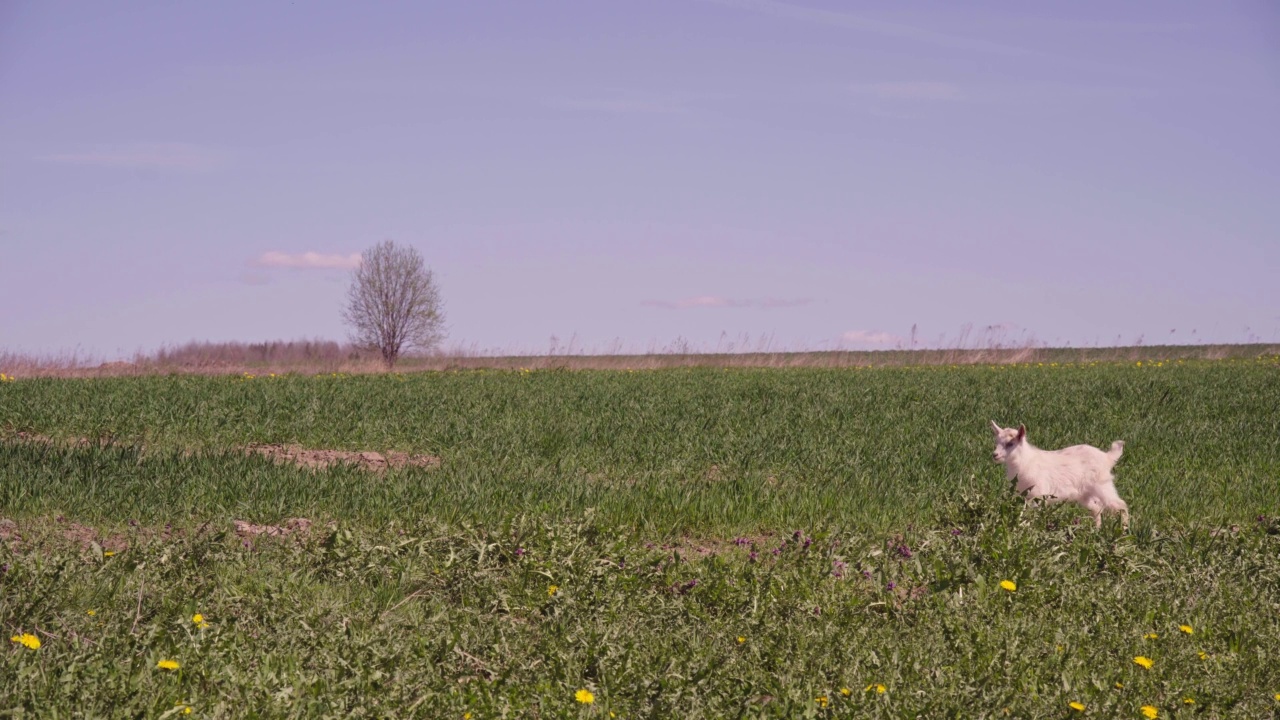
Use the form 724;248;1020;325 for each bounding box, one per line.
0;341;1280;378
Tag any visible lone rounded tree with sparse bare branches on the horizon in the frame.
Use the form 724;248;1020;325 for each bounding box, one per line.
342;240;444;369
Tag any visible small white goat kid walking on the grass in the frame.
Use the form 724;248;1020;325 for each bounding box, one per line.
991;420;1129;529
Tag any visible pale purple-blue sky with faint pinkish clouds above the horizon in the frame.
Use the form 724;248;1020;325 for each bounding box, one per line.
0;0;1280;357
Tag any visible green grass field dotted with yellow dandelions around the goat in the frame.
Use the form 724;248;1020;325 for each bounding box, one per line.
0;356;1280;720
